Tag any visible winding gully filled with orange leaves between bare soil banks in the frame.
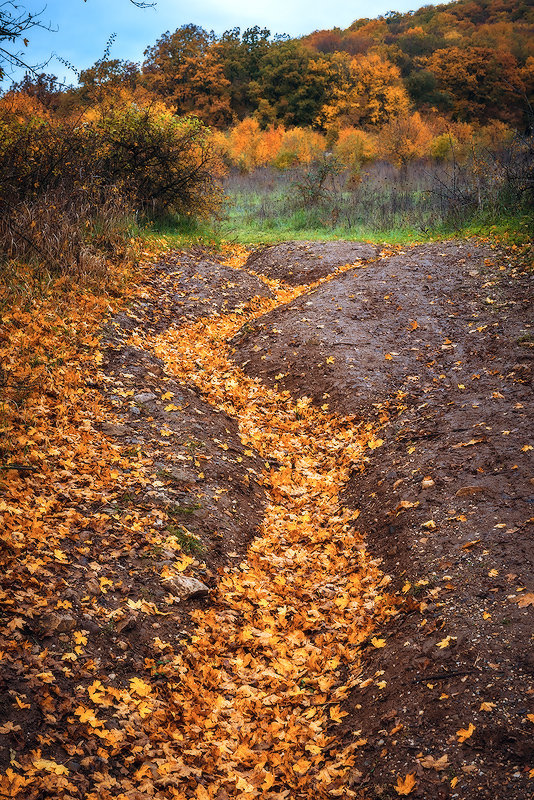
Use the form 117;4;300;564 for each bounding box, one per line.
132;248;395;798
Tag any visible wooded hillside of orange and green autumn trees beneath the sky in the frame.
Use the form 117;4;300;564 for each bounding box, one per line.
7;0;534;129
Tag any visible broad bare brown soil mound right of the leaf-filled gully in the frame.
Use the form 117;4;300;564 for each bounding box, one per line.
233;242;534;800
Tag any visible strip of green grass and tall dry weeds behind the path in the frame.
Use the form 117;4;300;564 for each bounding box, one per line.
146;143;534;253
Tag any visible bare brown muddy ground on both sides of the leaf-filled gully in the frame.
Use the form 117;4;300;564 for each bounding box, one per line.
0;241;534;800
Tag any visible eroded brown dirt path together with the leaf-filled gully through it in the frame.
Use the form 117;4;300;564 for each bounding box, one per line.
0;242;534;800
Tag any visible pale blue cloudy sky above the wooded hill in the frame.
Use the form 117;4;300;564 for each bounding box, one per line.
4;0;442;83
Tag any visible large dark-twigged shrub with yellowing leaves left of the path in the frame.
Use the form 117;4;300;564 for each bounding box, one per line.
0;98;221;271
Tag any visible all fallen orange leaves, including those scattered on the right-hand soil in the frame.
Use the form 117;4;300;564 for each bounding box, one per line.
0;239;534;800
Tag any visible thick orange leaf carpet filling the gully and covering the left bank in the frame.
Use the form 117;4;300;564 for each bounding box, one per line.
0;251;402;800
